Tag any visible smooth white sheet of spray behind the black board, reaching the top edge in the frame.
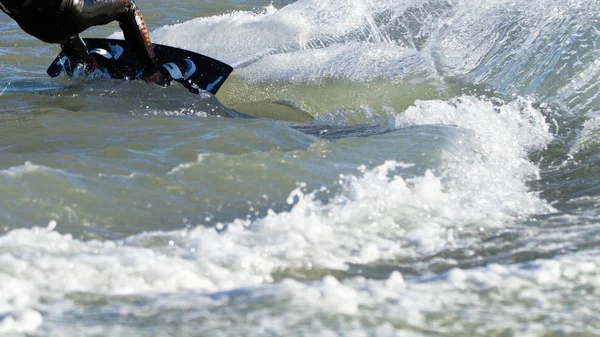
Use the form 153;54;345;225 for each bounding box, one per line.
131;0;432;82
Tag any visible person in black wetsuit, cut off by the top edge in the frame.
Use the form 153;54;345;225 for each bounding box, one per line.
0;0;162;83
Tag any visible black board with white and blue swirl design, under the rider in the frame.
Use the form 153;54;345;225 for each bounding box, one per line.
46;38;233;95
